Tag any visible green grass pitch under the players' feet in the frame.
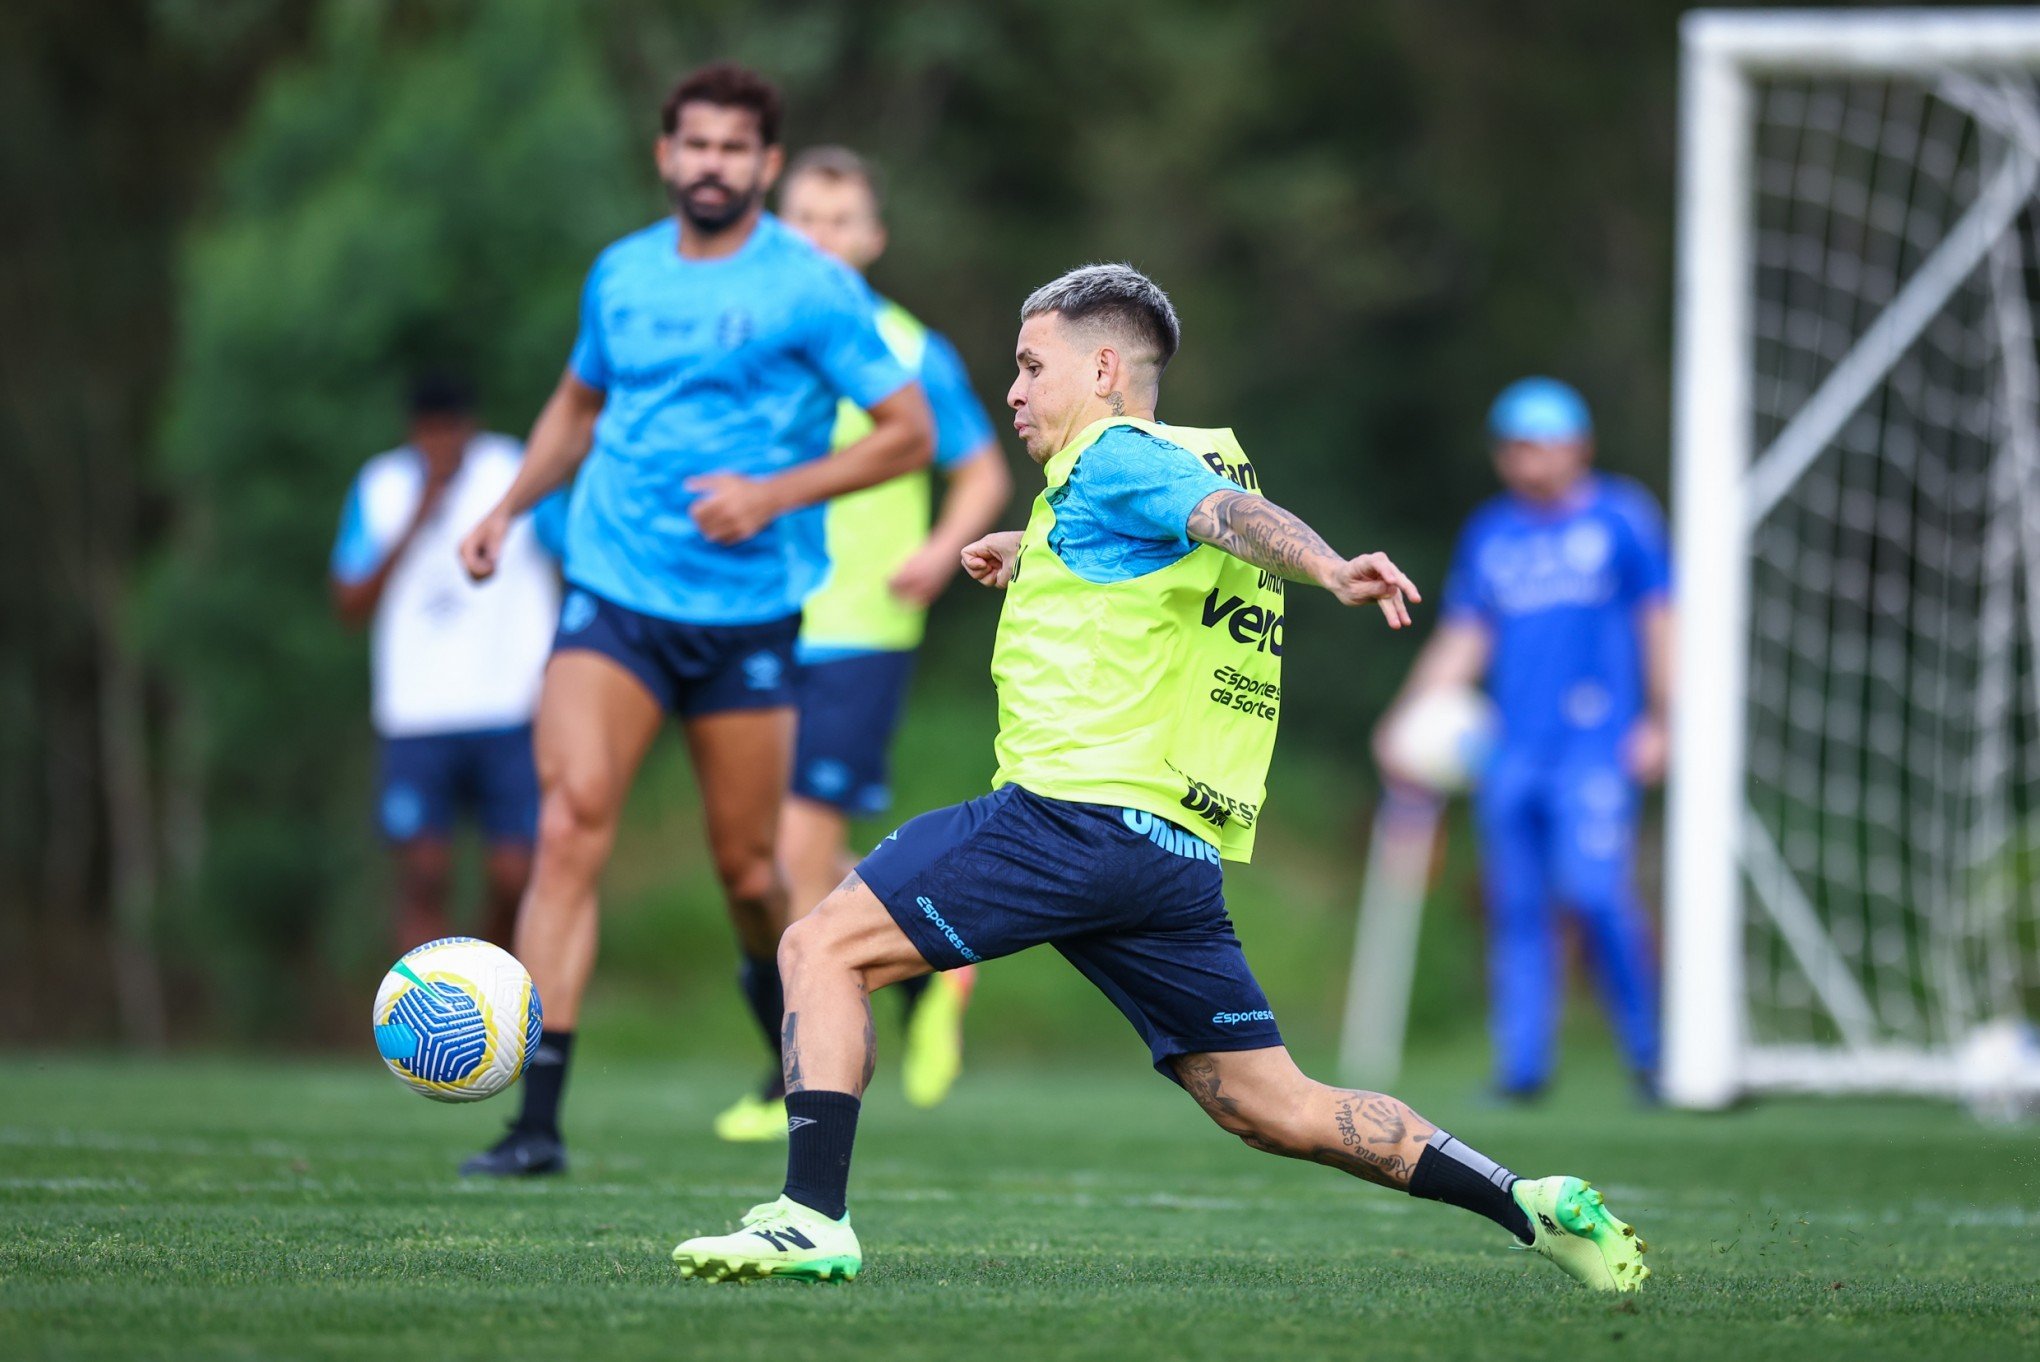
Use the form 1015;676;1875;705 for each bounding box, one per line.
0;1038;2040;1362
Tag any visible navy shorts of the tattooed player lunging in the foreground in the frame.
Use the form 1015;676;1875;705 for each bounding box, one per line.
857;785;1281;1079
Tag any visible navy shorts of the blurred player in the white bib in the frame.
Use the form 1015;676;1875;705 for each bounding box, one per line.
375;724;539;844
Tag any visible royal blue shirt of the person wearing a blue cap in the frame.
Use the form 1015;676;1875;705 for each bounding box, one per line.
1444;475;1671;756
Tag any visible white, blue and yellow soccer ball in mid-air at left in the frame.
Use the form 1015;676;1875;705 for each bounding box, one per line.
373;936;539;1101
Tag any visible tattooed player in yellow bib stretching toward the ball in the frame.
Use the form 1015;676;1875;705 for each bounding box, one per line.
673;265;1648;1291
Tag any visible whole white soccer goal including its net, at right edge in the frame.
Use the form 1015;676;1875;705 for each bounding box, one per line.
1665;10;2040;1105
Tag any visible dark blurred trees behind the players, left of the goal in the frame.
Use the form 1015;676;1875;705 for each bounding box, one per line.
0;0;1705;1042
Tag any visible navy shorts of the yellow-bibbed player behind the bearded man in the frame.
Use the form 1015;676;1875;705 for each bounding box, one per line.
794;650;914;816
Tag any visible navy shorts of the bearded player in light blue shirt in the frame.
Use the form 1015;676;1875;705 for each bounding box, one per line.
553;587;800;720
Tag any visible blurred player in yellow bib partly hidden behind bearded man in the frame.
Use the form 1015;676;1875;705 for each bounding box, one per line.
716;147;1012;1140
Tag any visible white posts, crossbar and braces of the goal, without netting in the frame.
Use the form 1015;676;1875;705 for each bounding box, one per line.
1663;8;2040;1109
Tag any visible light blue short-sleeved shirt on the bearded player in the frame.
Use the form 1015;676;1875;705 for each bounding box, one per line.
565;214;912;624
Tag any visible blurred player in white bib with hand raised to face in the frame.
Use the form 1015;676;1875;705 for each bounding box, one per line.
333;377;559;950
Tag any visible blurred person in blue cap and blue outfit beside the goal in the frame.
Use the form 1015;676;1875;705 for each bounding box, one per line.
1375;377;1671;1101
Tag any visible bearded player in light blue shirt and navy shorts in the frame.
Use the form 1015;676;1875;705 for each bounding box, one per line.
461;65;930;1174
